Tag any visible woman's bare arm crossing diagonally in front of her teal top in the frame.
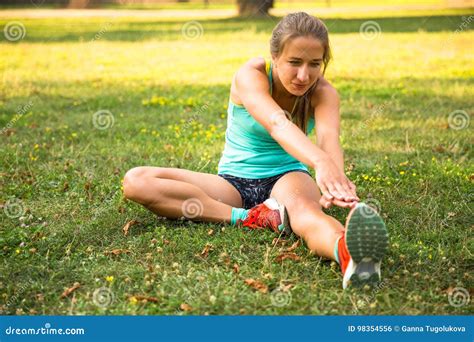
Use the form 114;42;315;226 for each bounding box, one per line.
235;62;356;201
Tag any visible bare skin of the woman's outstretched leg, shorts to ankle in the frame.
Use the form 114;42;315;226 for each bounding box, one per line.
271;172;344;260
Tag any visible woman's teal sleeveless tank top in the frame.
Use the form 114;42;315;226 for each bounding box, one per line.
217;62;314;179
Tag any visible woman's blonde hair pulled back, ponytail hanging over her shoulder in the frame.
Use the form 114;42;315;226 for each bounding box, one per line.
270;12;331;134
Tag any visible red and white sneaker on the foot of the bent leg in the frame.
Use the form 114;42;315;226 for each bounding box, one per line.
242;198;291;234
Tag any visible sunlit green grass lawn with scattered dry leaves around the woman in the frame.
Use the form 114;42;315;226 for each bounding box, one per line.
0;6;474;315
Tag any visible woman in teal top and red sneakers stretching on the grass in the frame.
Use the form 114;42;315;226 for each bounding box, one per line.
124;12;388;288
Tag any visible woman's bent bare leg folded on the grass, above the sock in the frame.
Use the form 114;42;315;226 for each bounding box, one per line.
123;166;242;222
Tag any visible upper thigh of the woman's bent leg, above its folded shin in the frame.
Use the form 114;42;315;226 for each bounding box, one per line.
125;166;242;207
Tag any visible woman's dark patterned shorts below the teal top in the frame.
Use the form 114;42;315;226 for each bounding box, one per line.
219;170;311;209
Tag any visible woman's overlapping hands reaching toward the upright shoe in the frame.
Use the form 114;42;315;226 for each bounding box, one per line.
315;158;359;209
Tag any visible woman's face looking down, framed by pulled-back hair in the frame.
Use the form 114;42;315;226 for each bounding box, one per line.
272;37;324;96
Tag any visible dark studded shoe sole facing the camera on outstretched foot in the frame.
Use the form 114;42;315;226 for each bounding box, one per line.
346;203;388;287
